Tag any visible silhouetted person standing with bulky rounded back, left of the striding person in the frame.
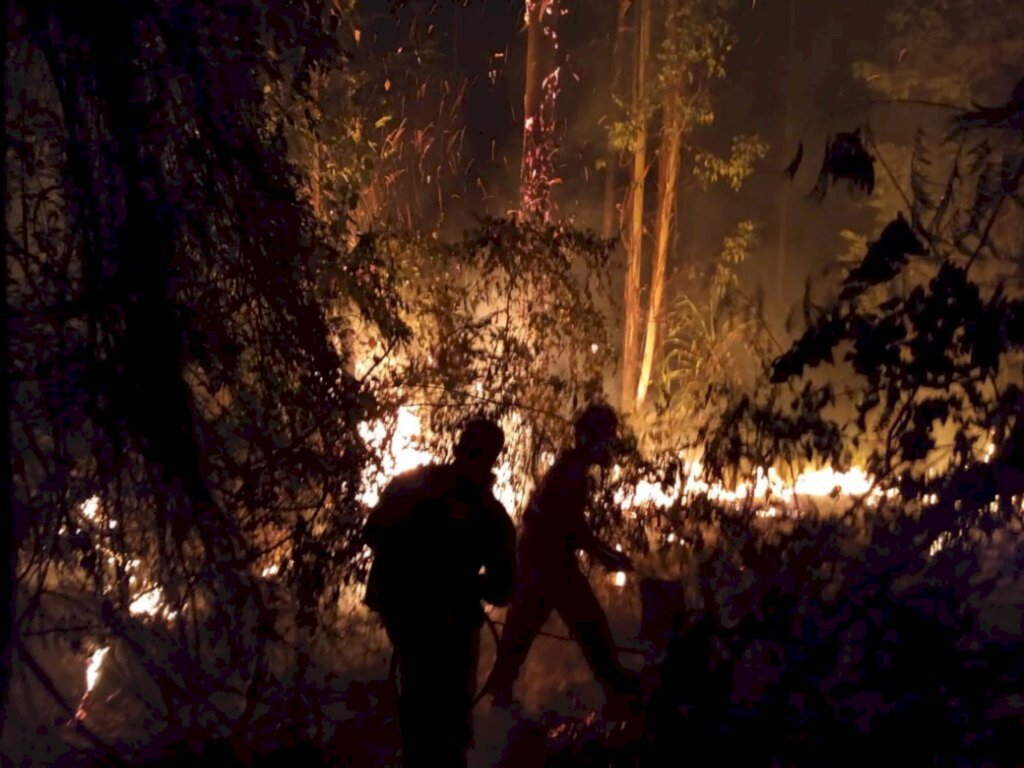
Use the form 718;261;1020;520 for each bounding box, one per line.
365;419;515;768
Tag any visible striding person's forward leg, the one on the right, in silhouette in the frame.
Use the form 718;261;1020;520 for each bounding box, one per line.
551;569;637;699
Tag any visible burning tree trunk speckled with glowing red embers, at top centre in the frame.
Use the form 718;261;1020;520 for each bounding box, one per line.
519;0;559;220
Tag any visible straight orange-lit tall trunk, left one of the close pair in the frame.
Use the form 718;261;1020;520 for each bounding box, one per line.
621;0;650;411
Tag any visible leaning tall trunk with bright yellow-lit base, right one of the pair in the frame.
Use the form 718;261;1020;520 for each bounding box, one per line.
636;2;684;408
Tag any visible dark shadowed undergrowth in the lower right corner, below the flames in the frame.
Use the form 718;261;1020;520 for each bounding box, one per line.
643;512;1022;766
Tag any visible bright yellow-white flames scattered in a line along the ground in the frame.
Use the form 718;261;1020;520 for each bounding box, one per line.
68;407;897;720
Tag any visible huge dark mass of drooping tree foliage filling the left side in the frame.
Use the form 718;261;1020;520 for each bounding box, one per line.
5;0;391;749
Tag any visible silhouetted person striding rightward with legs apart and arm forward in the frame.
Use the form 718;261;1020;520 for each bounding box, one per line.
485;404;637;707
